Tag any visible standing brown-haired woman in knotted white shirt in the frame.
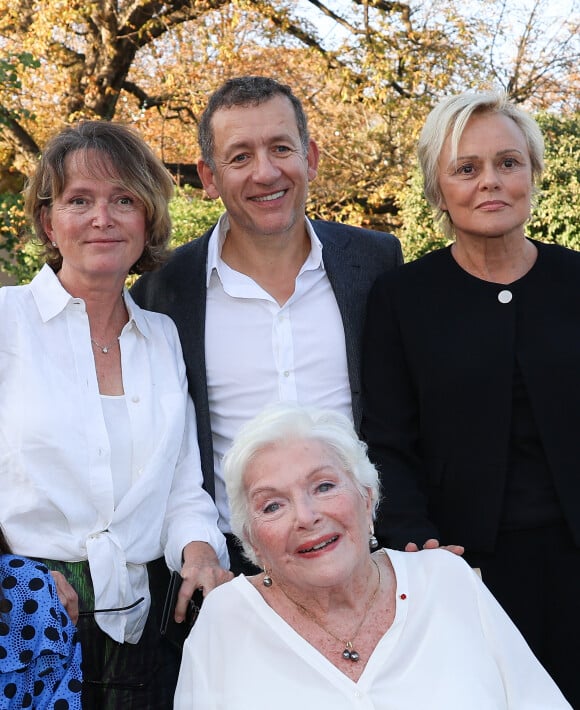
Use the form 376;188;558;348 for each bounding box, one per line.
0;121;231;710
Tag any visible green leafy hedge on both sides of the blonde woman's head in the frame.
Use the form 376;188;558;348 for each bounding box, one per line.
397;114;580;261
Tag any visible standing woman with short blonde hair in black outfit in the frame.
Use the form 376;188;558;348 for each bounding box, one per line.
362;91;580;708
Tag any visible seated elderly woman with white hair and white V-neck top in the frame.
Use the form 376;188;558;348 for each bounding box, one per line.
174;403;570;710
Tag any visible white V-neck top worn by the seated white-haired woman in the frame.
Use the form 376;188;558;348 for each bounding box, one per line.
174;550;571;710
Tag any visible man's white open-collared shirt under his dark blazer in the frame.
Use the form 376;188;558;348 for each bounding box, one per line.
205;214;352;532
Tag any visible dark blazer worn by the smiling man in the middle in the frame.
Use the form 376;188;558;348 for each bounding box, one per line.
131;220;403;496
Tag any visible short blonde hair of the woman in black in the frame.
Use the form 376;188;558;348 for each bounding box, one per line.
417;91;544;236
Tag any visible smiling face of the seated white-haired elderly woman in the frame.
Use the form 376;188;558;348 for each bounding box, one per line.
244;439;372;591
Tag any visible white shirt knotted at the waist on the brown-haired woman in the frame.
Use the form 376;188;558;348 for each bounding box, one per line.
0;266;229;643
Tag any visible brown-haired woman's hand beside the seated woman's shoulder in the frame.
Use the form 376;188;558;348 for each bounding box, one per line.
174;542;234;624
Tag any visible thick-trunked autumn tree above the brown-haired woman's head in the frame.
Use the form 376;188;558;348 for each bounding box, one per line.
0;0;238;172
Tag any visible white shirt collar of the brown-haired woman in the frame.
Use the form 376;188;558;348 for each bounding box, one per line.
30;264;151;338
